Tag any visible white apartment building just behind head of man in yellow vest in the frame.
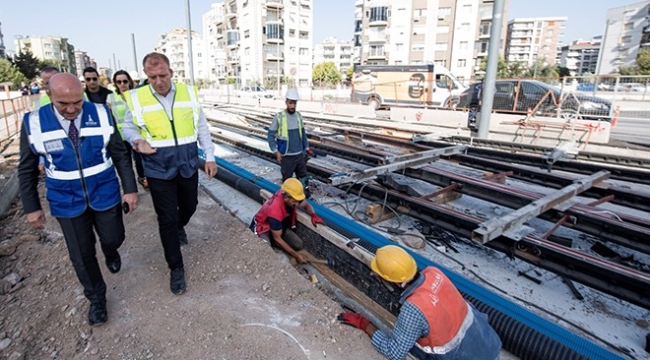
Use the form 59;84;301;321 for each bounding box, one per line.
154;28;208;82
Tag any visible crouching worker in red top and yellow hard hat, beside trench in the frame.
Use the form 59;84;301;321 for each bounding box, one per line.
250;178;324;264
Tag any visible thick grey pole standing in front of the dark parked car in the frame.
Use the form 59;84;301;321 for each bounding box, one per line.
478;0;505;139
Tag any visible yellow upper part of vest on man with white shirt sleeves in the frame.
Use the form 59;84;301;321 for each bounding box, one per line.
125;84;201;148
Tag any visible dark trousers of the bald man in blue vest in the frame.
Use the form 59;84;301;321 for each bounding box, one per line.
56;204;124;302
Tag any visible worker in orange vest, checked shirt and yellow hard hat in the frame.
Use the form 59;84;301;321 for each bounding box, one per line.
338;245;501;360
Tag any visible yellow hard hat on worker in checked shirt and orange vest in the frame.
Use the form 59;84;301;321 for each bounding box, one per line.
370;245;418;283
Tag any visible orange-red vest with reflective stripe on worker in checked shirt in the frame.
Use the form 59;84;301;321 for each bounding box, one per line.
406;267;474;354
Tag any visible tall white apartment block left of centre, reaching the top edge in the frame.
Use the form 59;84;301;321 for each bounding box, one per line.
204;0;313;87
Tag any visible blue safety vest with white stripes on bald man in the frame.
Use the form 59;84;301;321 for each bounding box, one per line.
23;101;121;218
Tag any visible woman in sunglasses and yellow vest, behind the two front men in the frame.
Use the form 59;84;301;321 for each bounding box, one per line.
107;70;149;189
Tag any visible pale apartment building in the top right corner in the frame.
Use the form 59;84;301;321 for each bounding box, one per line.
596;1;650;75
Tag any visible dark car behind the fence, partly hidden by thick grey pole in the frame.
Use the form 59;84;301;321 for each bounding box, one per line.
458;80;612;121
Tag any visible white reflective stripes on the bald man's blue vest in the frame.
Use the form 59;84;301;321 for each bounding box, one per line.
29;104;114;180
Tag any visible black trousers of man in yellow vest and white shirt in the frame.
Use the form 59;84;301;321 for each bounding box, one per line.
147;171;199;270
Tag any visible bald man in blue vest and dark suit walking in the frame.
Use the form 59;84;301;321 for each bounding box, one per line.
18;73;138;326
